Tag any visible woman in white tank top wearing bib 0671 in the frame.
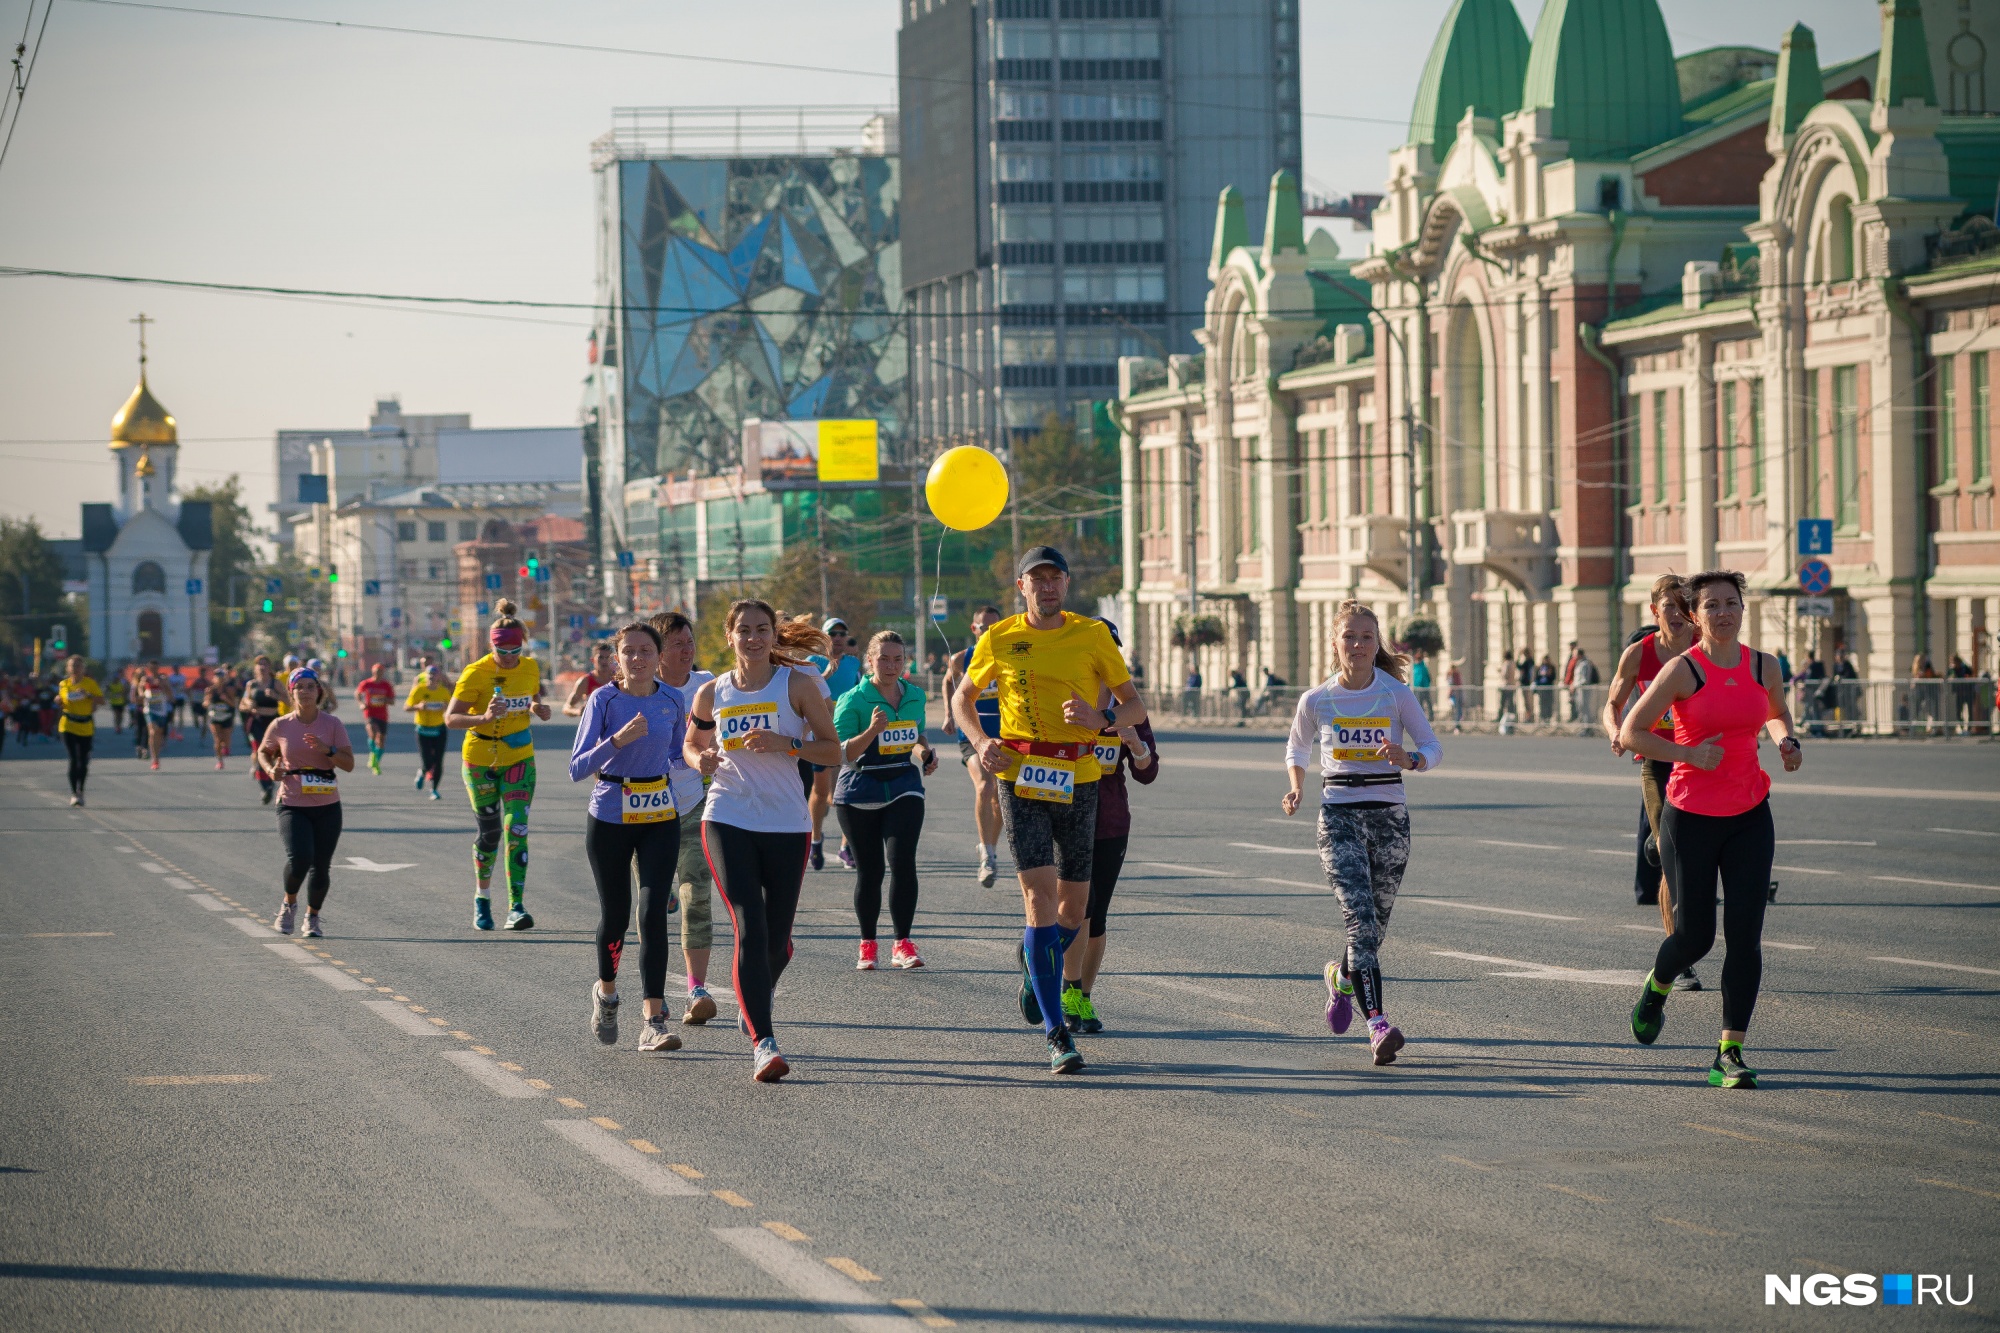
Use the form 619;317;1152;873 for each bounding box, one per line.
686;600;840;1083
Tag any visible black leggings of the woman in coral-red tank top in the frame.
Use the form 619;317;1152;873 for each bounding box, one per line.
1652;801;1778;1033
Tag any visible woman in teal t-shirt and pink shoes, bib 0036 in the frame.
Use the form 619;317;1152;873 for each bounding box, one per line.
834;630;938;973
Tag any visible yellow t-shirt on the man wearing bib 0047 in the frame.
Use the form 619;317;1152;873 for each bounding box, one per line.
966;610;1132;783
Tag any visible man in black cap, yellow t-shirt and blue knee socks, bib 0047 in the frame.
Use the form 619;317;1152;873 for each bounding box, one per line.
952;546;1146;1075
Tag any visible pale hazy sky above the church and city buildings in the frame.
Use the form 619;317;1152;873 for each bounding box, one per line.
0;0;1880;536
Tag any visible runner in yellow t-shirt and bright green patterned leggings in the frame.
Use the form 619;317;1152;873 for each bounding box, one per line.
444;598;550;931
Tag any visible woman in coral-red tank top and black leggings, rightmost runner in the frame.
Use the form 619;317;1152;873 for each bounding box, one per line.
1618;570;1804;1087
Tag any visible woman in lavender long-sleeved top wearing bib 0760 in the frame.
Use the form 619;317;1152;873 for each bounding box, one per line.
570;622;688;1051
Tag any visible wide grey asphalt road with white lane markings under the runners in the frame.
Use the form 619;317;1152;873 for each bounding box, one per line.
0;727;2000;1333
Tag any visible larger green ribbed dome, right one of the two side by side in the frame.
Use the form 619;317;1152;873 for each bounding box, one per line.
1520;0;1682;158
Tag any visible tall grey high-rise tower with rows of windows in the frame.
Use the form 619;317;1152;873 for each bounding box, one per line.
898;0;1300;448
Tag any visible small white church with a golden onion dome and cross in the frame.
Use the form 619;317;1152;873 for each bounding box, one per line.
82;316;214;667
